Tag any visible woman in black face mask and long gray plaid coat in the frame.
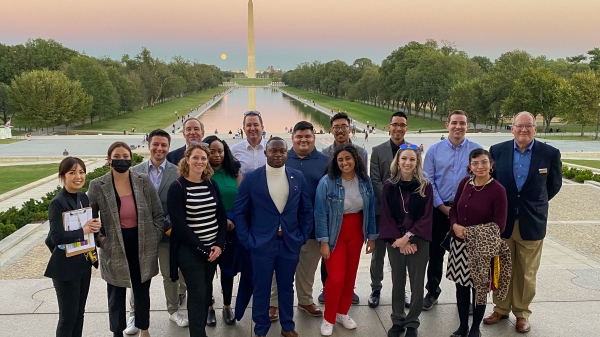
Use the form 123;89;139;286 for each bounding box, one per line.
88;142;163;337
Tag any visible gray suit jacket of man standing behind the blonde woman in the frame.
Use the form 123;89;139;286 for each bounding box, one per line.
369;139;406;215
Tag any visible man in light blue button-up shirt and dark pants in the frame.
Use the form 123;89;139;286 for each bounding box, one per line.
423;110;481;310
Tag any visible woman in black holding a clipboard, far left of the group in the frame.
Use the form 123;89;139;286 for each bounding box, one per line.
44;157;100;337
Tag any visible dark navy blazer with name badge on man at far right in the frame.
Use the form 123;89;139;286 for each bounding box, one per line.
490;140;562;240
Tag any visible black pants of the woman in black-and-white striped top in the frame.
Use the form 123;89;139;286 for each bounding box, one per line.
177;245;217;337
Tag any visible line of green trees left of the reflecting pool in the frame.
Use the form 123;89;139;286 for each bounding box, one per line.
0;39;222;133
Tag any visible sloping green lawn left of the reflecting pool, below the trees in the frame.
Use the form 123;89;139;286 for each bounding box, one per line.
69;87;226;133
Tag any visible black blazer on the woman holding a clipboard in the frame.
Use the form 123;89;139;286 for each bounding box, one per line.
44;188;92;281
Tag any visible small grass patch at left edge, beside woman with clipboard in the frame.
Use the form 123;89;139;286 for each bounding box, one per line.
0;163;58;194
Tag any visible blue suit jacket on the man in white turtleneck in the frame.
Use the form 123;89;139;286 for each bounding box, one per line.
233;166;313;255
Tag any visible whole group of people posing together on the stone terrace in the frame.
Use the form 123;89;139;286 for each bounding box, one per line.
46;110;562;337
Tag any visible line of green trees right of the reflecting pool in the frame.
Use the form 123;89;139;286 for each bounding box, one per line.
282;39;600;135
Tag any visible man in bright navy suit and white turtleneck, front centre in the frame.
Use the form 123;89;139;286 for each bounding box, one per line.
233;137;313;337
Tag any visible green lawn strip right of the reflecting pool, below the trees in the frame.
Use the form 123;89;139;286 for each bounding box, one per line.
282;87;446;131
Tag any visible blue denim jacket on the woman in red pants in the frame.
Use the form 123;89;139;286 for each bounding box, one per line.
315;175;379;251
